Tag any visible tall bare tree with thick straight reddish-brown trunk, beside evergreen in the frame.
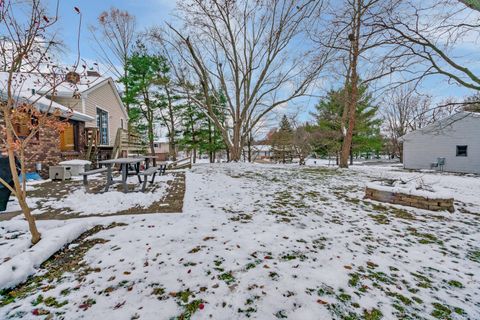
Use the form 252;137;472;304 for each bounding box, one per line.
312;0;409;168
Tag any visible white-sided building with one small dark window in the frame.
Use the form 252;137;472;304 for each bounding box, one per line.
402;112;480;174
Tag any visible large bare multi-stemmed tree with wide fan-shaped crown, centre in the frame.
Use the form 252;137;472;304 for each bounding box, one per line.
165;0;328;161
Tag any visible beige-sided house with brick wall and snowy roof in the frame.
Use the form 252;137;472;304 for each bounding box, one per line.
0;72;128;173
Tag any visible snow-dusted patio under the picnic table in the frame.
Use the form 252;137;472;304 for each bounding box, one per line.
0;173;181;220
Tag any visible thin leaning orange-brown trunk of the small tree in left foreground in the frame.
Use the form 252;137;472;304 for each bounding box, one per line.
4;116;41;244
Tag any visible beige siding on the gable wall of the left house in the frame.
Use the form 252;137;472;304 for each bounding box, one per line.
84;83;127;147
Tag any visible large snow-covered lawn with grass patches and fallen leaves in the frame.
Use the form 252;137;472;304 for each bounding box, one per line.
0;164;480;320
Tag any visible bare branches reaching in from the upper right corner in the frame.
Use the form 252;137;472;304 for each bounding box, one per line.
375;0;480;91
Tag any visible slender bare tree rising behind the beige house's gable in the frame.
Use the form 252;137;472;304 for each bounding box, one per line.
90;7;136;112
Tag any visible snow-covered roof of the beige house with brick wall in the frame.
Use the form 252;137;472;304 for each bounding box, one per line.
0;72;98;122
